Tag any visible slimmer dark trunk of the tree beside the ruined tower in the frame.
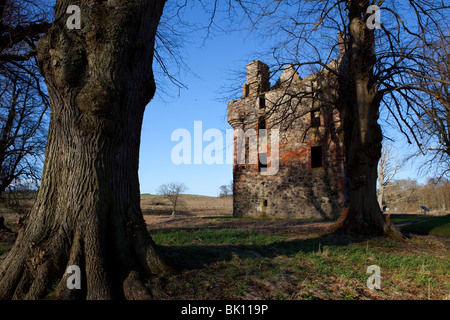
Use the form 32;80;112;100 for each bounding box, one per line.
336;1;397;238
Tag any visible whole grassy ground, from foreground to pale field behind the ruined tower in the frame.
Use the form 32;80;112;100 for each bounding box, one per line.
0;195;450;300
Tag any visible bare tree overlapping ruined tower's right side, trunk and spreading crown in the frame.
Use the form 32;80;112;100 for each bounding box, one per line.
209;0;449;236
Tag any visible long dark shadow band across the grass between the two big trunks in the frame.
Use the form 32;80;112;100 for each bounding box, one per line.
158;233;373;272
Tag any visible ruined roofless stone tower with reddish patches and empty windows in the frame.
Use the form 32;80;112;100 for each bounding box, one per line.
228;60;346;218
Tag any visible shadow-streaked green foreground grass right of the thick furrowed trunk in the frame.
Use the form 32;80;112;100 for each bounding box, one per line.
152;228;450;300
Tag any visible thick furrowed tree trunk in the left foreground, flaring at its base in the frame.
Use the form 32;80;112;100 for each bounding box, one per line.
0;0;171;299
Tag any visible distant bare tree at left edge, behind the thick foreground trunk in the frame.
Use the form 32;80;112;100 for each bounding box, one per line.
0;70;47;195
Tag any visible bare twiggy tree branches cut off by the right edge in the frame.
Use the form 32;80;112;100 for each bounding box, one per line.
405;29;450;178
